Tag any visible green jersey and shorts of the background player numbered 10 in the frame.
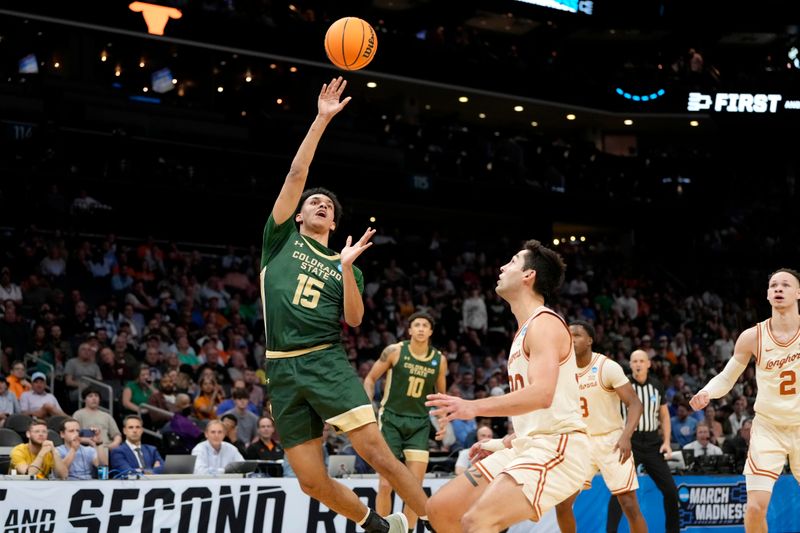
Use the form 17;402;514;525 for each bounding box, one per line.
380;341;442;463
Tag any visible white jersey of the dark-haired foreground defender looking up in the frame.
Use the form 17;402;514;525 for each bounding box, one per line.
508;306;586;437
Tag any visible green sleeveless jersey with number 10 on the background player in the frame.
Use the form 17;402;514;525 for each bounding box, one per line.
381;341;442;417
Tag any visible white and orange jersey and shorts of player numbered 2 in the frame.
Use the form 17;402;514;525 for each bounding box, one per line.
744;320;800;492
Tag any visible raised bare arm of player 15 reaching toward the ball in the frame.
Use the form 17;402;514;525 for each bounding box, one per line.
272;76;350;225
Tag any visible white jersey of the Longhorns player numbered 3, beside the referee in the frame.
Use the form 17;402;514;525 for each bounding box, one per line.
578;353;630;435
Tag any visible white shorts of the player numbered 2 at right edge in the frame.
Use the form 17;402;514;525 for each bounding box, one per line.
744;415;800;492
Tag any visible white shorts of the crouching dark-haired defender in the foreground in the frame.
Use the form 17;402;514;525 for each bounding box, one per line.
475;432;589;522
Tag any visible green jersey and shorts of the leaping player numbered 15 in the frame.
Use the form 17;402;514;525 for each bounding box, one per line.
261;215;375;448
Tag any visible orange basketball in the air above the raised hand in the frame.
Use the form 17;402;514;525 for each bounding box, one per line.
325;17;378;70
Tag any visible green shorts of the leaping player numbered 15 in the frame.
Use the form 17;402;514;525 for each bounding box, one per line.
267;346;375;448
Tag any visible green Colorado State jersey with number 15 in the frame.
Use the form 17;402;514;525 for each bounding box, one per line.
261;214;364;356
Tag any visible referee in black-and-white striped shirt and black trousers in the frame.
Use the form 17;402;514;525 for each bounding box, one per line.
606;350;679;533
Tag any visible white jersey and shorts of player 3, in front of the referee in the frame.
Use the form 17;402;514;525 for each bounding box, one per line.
578;353;639;494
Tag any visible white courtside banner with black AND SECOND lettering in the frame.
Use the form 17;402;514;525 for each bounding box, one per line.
0;477;448;533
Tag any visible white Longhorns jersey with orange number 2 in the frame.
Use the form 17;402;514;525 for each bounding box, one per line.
754;320;800;426
